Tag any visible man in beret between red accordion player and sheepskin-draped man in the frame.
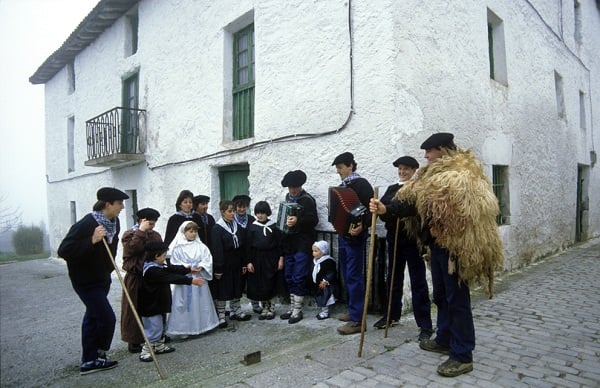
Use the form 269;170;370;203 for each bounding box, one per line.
373;156;433;341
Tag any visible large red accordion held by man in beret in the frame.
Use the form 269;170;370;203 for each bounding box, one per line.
328;186;367;237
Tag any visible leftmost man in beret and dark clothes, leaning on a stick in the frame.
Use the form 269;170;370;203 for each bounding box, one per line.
58;187;129;375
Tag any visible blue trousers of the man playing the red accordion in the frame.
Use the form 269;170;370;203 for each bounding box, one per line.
338;233;367;322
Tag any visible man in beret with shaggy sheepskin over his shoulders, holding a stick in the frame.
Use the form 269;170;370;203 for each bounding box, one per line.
370;133;504;377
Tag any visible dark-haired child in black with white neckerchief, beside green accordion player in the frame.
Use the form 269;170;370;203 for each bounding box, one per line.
247;201;283;320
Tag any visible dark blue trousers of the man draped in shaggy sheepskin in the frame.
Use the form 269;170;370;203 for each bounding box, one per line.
430;244;475;362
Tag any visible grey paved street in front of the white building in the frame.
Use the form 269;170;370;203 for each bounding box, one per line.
0;239;600;387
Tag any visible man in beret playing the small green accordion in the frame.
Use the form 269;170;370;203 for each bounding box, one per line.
280;170;319;324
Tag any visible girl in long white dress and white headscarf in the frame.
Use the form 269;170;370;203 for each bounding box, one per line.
167;221;219;337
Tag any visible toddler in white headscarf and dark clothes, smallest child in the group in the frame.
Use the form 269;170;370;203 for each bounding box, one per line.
312;240;337;320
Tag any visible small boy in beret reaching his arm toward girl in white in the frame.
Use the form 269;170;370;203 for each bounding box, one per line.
138;241;207;362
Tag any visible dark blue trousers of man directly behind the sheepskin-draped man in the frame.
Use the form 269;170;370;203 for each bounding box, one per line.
385;233;433;329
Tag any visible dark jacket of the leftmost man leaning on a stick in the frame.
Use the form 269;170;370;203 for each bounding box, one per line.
58;213;121;286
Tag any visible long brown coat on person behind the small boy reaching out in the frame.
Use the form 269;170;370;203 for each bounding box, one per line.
121;229;162;344
